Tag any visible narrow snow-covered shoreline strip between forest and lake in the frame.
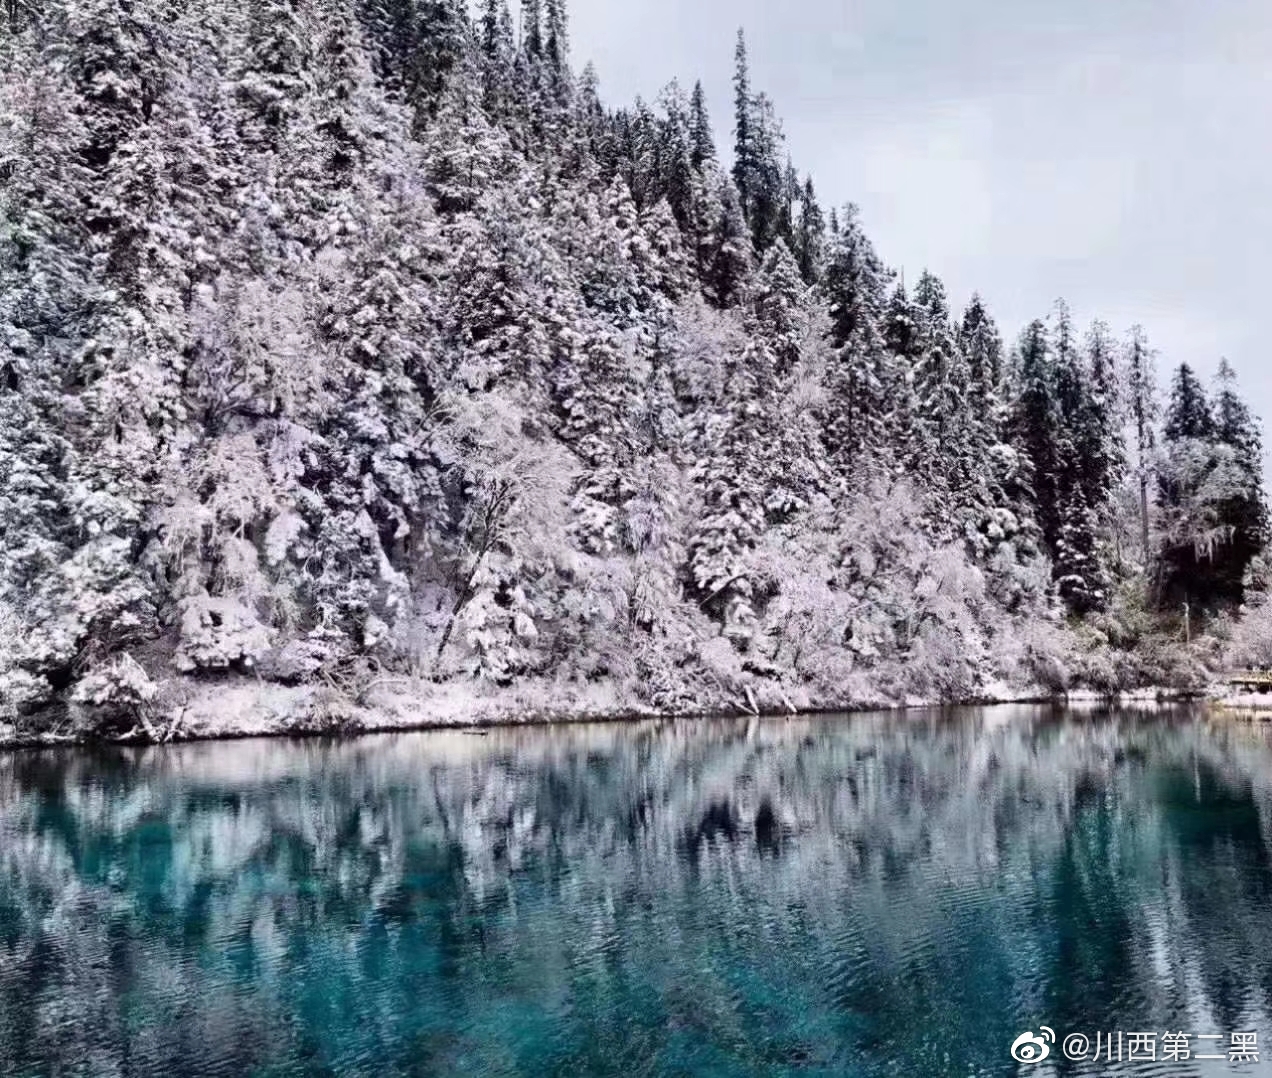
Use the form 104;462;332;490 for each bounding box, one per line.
0;678;1221;752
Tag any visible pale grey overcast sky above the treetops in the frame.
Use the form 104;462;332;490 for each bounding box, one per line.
570;0;1272;430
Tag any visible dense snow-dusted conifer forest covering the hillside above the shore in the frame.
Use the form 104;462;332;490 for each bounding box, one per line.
0;0;1268;722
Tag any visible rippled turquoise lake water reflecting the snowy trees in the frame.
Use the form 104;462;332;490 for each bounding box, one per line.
0;708;1272;1078
